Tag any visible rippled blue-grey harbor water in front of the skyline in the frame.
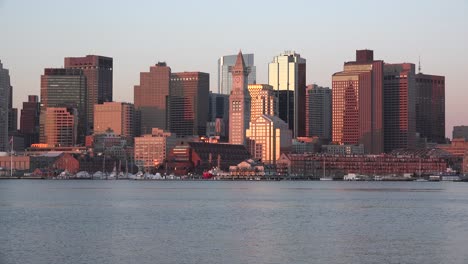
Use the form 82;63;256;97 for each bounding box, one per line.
0;180;468;264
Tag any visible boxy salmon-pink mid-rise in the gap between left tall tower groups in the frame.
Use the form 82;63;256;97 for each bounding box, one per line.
94;102;135;139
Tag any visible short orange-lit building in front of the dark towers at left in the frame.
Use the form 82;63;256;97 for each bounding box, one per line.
39;107;79;147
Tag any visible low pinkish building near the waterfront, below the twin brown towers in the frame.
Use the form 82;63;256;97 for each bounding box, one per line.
134;128;176;169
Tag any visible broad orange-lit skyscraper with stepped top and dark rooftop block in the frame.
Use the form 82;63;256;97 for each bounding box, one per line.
332;50;383;154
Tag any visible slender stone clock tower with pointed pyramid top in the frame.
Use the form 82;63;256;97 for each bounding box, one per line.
229;51;250;145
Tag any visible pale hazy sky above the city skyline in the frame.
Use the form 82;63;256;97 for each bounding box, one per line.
0;0;468;136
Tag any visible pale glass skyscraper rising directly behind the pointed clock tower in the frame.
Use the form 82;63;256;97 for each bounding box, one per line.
218;54;257;95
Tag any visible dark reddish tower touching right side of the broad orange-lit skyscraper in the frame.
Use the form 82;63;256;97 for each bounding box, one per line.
383;63;416;152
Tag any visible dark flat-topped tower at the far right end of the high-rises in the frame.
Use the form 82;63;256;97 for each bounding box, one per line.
416;73;445;144
